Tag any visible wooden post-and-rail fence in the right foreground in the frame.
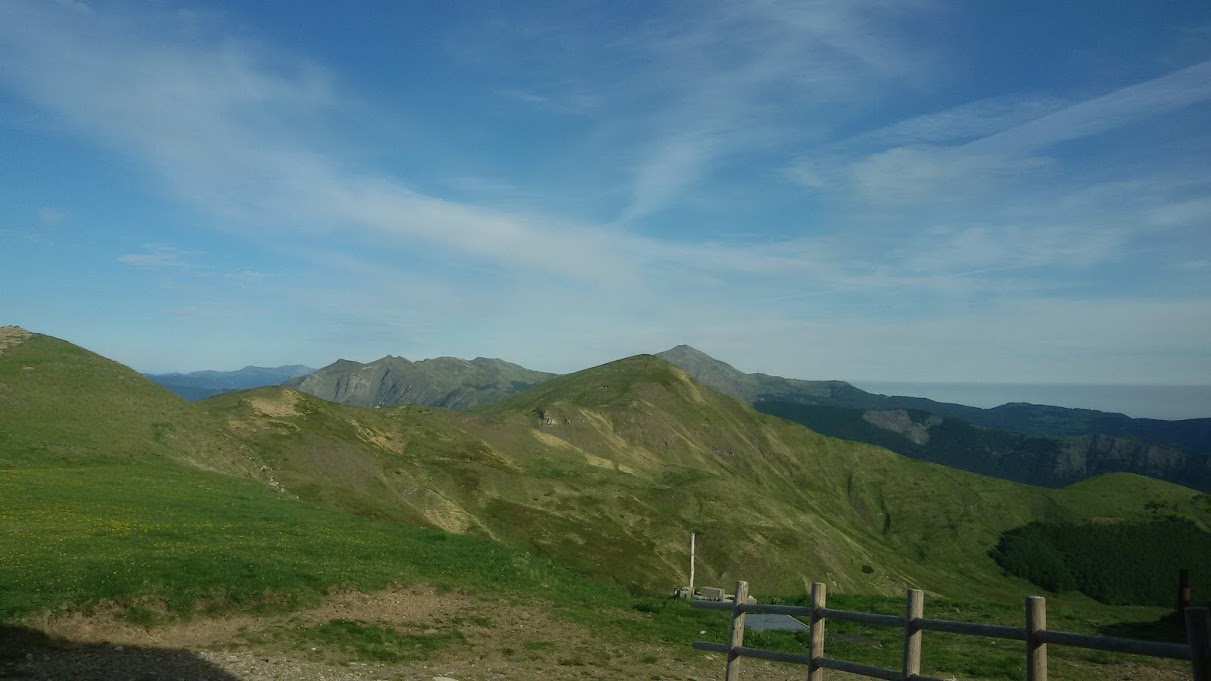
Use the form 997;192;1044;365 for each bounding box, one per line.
690;582;1211;681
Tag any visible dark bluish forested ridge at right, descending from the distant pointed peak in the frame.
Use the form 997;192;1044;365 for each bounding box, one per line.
659;345;1211;491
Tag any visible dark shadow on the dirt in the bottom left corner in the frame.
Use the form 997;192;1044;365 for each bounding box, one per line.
0;624;239;681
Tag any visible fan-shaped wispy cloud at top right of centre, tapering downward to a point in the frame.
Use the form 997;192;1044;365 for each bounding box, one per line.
621;1;930;221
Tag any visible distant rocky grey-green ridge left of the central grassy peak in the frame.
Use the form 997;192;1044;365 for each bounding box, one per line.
285;355;555;410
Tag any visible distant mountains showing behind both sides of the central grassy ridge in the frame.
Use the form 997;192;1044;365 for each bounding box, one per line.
144;345;1211;491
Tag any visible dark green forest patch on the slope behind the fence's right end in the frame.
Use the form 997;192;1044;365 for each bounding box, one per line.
991;517;1211;606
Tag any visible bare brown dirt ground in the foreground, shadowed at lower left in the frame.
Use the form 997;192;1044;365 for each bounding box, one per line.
0;588;843;681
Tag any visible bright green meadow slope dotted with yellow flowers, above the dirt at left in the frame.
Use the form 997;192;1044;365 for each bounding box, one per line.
0;460;621;622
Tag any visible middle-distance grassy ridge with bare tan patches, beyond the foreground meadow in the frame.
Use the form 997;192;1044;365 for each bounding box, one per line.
0;327;1211;595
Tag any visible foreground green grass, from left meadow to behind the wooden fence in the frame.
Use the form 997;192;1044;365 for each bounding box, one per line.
0;453;1191;681
